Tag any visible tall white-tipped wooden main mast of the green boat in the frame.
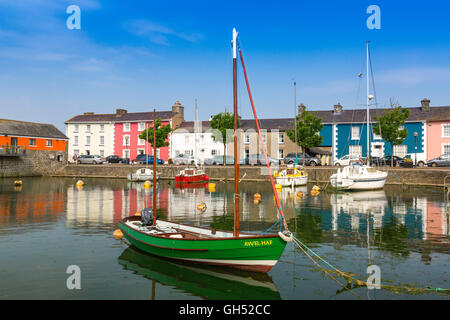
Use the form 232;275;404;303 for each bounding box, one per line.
232;28;239;237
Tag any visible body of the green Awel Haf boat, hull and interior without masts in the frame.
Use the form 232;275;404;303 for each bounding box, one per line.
119;216;286;272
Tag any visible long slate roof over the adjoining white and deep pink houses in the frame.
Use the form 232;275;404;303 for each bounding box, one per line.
64;111;175;123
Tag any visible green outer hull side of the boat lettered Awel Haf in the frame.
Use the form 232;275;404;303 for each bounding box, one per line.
118;221;286;272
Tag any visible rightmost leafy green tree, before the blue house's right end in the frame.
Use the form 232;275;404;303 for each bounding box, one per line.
373;106;409;167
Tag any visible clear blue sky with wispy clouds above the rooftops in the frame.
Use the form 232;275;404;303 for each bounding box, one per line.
0;0;450;130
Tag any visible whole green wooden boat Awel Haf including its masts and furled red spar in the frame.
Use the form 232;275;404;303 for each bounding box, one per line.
118;29;292;272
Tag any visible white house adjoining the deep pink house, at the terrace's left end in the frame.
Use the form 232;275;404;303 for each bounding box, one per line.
65;112;114;161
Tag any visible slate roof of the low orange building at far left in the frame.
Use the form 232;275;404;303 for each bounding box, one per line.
0;119;68;139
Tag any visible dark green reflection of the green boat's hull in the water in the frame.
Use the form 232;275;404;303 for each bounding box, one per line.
118;247;281;300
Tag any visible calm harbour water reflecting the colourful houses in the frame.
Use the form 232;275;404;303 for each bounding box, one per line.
0;178;450;300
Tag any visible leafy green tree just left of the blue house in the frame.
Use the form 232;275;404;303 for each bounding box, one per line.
286;108;323;165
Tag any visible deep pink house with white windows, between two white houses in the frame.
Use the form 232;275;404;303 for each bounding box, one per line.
114;101;184;163
